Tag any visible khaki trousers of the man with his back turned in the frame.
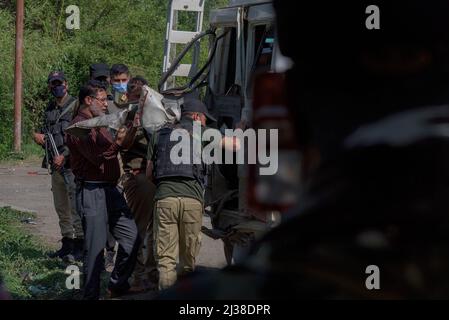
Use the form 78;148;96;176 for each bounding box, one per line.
154;197;203;290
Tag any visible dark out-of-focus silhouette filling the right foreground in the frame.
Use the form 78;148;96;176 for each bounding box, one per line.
162;0;449;299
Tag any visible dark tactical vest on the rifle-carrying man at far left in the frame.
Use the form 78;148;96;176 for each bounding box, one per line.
42;96;76;156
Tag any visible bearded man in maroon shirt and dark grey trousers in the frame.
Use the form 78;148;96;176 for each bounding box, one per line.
67;80;140;299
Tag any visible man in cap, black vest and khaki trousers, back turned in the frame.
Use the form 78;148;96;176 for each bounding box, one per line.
147;98;239;290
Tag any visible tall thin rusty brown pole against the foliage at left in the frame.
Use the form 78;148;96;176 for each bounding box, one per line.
14;0;24;152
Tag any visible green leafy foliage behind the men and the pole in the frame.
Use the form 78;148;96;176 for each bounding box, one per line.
0;0;228;159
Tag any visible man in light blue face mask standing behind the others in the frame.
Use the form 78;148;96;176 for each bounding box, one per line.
108;64;131;113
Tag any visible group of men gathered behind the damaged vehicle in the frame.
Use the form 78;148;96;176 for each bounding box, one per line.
34;64;228;299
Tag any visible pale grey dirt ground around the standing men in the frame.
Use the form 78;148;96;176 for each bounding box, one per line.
0;161;226;296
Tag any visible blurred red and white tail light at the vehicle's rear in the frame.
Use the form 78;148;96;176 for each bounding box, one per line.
248;73;300;218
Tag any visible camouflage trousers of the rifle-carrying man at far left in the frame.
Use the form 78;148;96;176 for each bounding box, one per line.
51;169;84;239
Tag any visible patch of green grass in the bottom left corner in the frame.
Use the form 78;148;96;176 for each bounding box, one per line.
0;208;81;299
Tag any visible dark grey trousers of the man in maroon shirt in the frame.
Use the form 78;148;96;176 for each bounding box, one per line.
76;183;141;299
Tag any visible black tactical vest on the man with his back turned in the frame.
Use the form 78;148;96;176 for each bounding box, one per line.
154;122;206;186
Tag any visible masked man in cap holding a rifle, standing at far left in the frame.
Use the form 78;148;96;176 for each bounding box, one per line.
33;71;84;260
